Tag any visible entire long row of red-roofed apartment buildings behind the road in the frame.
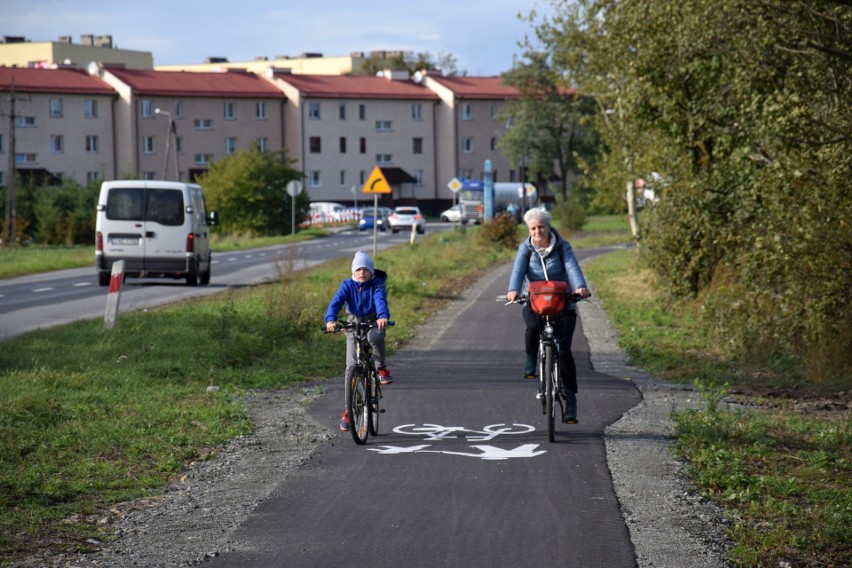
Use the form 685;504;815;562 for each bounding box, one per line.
0;64;520;212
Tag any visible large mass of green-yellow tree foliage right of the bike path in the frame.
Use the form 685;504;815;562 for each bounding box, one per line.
536;0;852;380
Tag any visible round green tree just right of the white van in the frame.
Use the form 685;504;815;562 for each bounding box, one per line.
199;145;310;235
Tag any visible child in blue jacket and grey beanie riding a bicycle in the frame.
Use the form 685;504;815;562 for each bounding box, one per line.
325;250;393;431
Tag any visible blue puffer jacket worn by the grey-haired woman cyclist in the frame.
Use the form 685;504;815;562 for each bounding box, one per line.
508;229;588;309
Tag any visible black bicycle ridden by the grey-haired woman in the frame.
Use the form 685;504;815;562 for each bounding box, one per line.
506;294;583;442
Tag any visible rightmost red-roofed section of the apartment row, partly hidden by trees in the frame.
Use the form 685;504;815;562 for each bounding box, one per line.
415;73;520;189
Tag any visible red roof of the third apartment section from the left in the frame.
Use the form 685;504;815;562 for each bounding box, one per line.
275;74;438;100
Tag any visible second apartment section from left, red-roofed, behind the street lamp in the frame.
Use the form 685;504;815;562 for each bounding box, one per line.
92;65;286;180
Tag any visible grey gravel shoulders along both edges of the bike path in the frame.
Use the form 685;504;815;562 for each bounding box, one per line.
46;262;731;568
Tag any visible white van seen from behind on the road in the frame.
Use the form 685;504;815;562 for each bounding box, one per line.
95;180;218;286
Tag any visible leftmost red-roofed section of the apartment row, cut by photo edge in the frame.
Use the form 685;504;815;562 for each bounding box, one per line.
0;67;117;185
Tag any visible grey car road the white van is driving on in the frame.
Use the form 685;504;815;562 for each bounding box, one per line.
0;223;418;341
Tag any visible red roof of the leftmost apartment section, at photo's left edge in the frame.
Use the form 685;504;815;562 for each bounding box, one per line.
0;67;116;95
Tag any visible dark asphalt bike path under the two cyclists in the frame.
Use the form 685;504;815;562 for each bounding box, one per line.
208;247;641;568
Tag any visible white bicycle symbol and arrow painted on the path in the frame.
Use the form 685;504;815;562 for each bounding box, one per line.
367;424;547;460
